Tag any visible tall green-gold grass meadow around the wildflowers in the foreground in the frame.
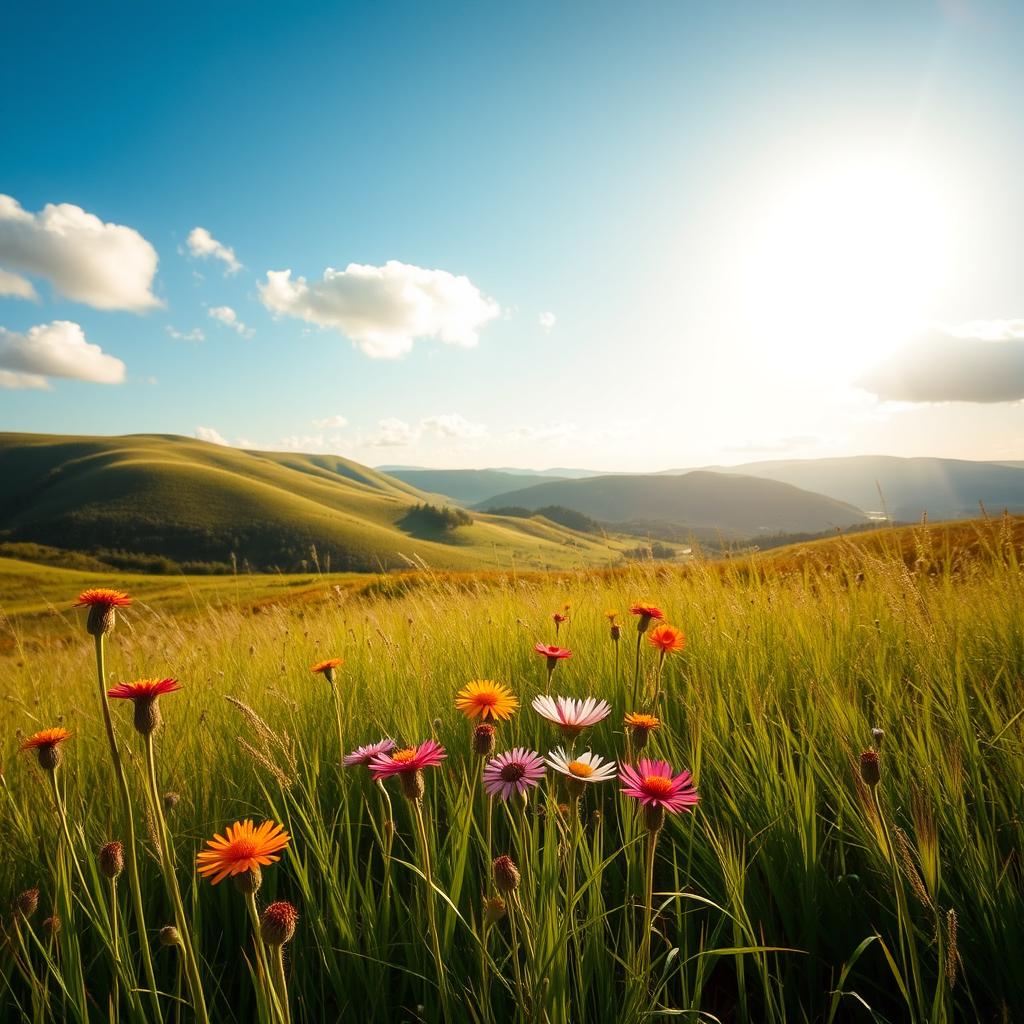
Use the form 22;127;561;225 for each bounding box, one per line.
0;520;1024;1024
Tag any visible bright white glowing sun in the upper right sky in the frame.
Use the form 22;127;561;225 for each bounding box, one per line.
738;149;953;380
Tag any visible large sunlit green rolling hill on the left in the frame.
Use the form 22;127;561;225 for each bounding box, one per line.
0;434;616;571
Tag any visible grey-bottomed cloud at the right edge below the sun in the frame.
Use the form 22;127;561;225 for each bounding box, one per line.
858;321;1024;403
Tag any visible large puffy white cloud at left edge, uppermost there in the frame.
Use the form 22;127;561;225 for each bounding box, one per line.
0;195;163;312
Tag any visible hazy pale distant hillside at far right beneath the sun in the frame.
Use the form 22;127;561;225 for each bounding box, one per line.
674;456;1024;521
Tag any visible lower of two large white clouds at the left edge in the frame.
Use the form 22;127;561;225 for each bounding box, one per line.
0;321;125;387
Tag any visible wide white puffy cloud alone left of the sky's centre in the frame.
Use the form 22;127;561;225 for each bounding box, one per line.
260;260;501;359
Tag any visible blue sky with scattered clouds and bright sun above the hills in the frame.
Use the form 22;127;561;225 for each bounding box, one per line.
0;0;1024;471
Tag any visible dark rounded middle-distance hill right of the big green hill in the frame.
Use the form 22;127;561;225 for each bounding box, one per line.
482;470;867;537
